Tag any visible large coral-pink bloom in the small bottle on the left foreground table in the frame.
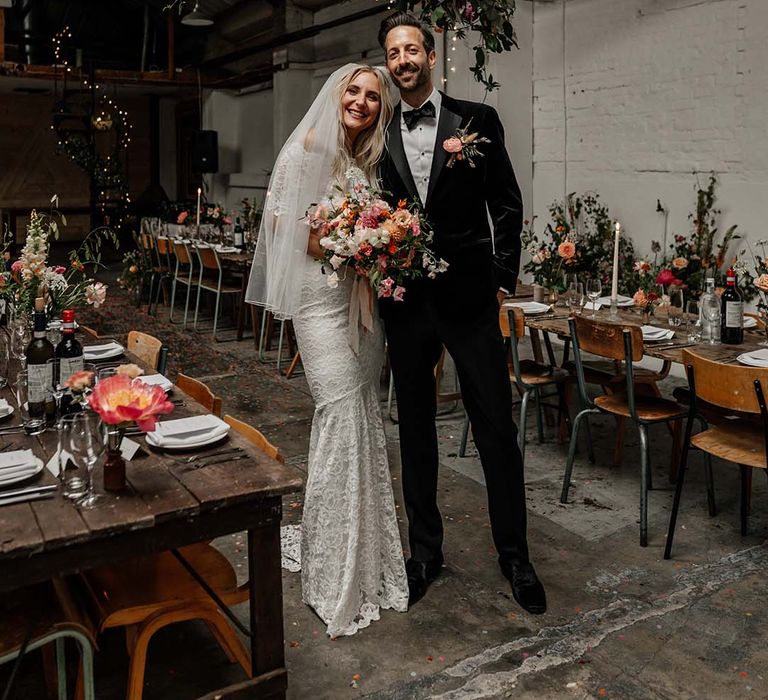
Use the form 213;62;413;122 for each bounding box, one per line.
88;374;173;432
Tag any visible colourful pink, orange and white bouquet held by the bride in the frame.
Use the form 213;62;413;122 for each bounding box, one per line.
309;174;448;301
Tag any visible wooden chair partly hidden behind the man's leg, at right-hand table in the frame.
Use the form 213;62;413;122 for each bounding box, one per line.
459;307;571;460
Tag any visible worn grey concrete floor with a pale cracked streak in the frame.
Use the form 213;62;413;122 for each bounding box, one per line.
0;330;768;700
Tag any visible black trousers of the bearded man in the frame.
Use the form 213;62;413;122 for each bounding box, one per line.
382;256;528;561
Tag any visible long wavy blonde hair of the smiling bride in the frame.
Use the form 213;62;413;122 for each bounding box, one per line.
333;66;394;183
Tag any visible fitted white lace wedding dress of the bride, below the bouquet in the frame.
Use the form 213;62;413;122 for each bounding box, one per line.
293;175;408;637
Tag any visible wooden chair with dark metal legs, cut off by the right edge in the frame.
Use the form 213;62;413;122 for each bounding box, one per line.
664;350;768;559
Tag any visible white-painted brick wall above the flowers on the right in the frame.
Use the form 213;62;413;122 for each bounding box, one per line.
533;0;768;258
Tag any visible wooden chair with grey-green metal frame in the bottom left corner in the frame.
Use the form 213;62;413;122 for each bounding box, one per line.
0;579;96;700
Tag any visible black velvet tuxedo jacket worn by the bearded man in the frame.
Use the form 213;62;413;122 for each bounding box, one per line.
379;93;523;291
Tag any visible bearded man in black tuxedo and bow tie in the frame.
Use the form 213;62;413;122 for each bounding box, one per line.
379;12;547;614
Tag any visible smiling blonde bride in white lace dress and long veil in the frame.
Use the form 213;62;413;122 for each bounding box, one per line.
246;64;408;637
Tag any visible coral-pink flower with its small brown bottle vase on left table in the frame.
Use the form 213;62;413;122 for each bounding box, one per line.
88;365;173;491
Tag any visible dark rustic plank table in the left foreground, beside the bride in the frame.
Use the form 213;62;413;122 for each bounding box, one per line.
0;337;303;698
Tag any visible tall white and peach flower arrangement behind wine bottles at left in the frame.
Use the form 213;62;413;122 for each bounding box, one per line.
0;202;118;318
